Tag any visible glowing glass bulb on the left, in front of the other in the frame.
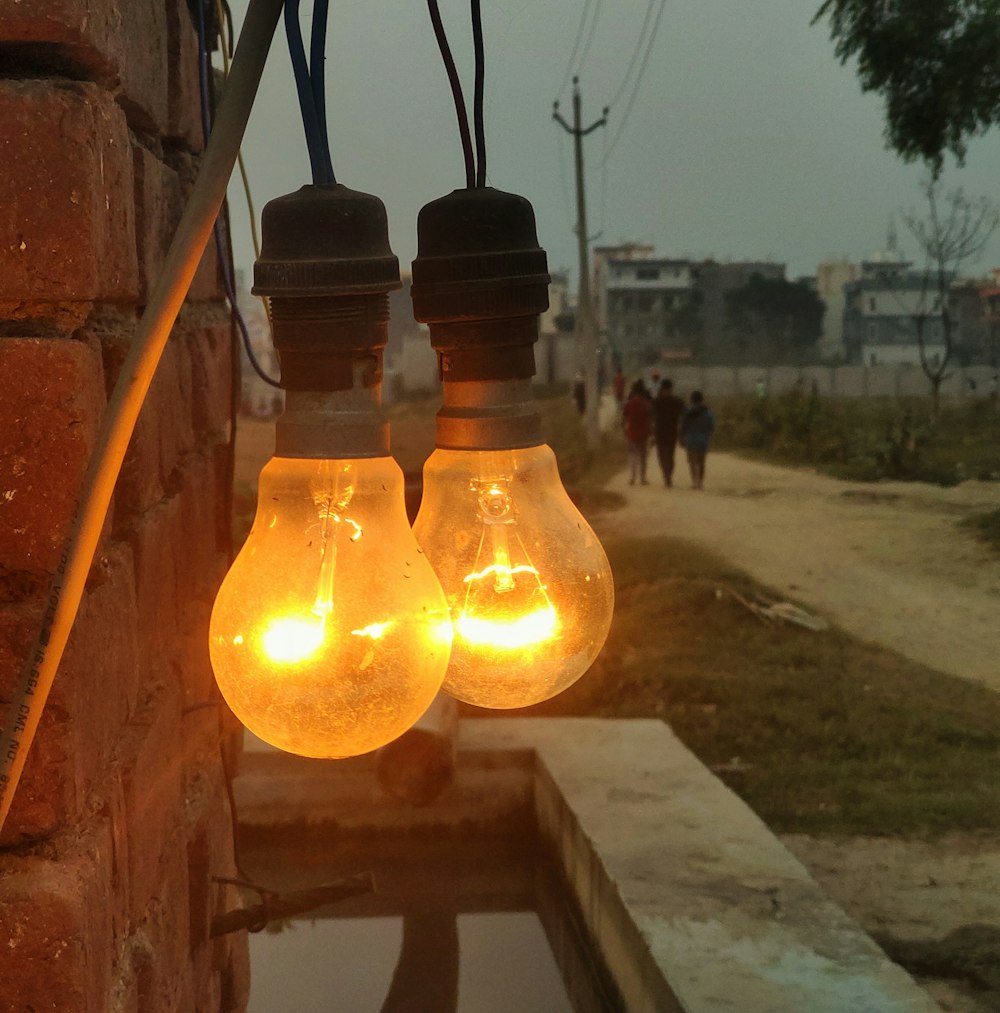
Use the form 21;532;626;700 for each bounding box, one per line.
210;457;451;758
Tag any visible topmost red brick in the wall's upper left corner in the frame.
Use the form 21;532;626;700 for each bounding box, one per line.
0;0;167;129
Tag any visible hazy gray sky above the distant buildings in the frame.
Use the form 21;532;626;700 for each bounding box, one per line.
222;0;1000;287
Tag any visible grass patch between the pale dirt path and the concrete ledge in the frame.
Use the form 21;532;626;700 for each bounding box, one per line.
468;538;1000;835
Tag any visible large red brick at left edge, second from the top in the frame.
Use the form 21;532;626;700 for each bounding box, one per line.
0;81;138;302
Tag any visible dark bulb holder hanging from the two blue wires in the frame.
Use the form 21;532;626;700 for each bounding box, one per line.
252;183;400;391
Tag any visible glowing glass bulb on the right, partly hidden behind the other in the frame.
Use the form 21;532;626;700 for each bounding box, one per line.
413;446;614;708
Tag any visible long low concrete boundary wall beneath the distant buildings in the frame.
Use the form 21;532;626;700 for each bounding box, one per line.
660;366;996;398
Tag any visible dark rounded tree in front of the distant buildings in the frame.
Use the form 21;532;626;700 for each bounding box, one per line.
724;274;826;362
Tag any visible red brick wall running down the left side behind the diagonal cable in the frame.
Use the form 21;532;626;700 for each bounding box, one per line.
0;0;248;1013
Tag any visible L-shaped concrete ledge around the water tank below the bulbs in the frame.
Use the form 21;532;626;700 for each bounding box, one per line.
236;718;938;1013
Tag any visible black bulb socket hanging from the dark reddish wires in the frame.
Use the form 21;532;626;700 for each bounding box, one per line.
410;186;549;382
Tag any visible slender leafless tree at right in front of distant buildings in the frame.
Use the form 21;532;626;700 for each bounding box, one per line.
903;177;1000;418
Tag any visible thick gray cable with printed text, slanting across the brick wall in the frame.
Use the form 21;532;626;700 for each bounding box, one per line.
0;0;284;829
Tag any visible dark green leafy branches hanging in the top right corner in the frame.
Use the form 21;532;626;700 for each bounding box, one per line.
813;0;1000;178
